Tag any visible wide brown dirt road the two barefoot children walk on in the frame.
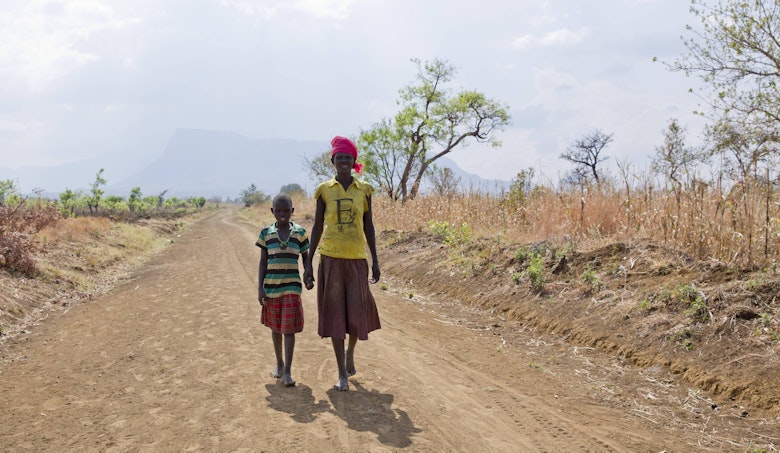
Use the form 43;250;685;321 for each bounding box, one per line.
0;210;772;452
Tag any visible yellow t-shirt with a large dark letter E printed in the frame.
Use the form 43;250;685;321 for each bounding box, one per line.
314;177;374;259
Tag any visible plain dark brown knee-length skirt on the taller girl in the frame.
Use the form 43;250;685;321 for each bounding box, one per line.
317;255;382;340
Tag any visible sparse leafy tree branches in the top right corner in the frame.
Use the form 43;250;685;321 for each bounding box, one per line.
667;0;780;135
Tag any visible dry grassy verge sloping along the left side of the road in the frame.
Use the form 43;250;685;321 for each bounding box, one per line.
0;217;189;340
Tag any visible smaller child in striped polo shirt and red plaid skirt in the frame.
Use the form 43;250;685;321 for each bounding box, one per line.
255;193;314;387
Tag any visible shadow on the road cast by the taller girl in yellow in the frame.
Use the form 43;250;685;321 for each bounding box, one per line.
326;381;421;448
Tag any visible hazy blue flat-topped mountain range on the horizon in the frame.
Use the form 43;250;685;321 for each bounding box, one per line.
0;129;509;199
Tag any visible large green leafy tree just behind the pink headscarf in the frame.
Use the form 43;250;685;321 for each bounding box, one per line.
358;59;510;201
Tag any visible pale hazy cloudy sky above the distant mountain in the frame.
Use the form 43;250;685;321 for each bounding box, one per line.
0;0;700;180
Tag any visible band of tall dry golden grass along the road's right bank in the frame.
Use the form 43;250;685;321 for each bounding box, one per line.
374;176;780;268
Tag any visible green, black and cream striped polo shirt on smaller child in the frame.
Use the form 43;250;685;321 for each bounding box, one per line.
255;221;309;298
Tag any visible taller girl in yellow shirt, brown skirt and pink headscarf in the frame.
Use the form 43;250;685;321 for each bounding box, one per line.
303;136;381;391
